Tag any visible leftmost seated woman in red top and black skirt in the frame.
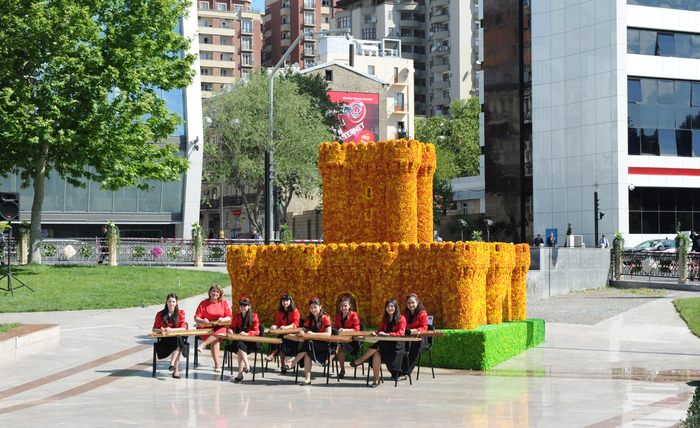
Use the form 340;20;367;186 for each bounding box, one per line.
153;293;187;379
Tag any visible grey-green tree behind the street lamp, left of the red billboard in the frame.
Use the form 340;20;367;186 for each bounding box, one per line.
203;72;332;236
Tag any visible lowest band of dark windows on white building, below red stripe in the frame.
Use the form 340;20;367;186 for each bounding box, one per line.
629;187;700;234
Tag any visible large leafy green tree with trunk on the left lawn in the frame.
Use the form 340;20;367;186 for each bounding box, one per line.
0;0;196;262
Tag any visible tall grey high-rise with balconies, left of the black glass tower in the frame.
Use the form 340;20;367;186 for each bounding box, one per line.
331;0;483;116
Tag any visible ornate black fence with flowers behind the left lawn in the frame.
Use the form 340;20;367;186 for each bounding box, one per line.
0;238;322;265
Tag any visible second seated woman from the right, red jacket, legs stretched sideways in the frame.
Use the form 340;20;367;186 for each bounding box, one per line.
350;299;406;388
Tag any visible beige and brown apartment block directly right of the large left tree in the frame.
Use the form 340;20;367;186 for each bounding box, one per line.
197;0;263;98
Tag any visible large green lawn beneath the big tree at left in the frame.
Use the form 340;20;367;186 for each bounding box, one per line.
0;265;231;313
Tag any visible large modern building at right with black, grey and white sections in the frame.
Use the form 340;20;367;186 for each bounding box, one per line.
483;0;700;247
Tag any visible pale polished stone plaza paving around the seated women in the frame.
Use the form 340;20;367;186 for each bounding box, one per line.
0;266;700;428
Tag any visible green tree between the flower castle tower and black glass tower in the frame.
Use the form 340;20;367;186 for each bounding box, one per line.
416;97;481;224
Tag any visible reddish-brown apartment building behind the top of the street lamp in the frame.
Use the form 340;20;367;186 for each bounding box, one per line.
263;0;336;69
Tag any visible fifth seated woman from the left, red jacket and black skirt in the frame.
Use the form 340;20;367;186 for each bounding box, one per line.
283;297;331;386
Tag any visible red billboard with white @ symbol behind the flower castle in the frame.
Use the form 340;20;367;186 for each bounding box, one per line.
328;92;379;143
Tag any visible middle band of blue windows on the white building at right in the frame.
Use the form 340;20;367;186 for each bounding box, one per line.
627;78;700;157
